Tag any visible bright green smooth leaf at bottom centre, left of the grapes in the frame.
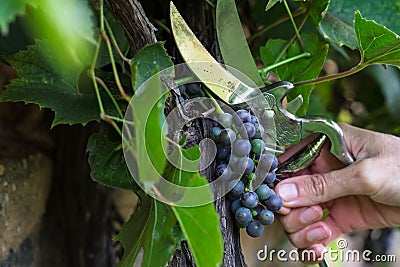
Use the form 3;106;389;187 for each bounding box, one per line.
172;173;223;267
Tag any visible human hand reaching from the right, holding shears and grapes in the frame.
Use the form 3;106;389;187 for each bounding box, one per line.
276;124;400;262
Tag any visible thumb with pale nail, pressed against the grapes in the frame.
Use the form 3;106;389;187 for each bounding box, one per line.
276;159;376;208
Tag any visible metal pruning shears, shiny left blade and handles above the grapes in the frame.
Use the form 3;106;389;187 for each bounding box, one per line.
170;2;354;267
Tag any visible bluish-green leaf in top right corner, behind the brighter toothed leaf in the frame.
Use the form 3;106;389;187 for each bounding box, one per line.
321;0;400;49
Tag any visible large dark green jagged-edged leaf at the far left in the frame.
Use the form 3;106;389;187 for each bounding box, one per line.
0;41;104;126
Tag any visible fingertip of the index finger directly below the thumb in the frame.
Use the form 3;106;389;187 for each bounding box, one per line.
279;206;323;234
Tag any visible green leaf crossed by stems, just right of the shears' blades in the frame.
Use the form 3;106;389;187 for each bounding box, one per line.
260;35;328;115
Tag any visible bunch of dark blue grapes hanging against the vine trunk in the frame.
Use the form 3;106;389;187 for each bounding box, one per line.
210;110;282;237
